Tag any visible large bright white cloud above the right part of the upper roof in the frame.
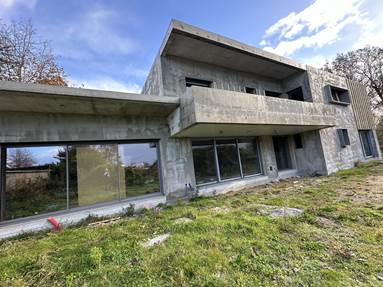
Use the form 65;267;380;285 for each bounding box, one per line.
261;0;365;56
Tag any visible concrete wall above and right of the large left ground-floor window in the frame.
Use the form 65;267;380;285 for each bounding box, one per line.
0;112;194;198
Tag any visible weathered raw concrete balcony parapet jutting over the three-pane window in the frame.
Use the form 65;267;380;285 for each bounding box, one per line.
170;87;335;136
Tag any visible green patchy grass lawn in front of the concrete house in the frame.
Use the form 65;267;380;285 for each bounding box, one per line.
0;162;383;286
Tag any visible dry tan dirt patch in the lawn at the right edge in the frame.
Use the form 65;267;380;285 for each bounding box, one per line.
341;175;383;204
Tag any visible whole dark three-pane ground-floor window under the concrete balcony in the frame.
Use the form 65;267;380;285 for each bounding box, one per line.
192;138;261;185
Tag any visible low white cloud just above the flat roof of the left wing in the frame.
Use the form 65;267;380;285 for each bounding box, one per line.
69;76;141;93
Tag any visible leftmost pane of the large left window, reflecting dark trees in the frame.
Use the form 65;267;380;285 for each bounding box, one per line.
5;146;67;220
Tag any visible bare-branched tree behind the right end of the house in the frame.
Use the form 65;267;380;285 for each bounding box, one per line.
324;46;383;111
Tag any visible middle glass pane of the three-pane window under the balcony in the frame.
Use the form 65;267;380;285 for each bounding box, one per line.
216;139;241;179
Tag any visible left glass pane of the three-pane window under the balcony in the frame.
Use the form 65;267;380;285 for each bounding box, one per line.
192;140;217;184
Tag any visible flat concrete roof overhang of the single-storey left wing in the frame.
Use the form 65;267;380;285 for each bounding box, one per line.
0;81;179;116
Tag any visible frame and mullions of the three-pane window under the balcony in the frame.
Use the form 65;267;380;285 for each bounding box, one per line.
192;137;264;187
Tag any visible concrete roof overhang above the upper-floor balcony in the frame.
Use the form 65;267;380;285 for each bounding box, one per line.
160;20;306;80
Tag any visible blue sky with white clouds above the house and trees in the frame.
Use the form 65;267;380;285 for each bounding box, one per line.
0;0;383;92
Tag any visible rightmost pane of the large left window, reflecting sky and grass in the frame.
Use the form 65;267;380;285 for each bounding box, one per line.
118;143;160;198
